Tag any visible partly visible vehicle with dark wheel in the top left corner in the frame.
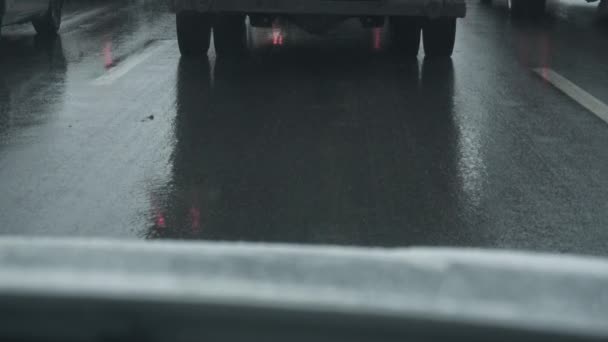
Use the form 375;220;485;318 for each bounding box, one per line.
0;0;63;35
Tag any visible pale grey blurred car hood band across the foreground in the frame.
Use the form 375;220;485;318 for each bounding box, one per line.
0;237;608;337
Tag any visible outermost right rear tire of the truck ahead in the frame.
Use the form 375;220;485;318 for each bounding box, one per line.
422;17;456;58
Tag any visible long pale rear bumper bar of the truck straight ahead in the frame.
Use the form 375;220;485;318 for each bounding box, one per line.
169;0;466;17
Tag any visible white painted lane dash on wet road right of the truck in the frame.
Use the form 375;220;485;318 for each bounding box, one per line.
534;68;608;123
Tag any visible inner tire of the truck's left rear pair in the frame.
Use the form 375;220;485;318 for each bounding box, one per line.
213;14;247;57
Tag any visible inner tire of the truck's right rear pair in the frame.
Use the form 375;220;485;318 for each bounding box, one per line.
389;17;422;57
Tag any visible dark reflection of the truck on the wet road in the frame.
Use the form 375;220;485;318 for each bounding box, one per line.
146;50;475;246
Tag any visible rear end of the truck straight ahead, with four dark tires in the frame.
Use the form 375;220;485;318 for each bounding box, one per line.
170;0;466;57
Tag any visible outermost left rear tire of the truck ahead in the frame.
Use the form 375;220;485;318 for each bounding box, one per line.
176;11;211;57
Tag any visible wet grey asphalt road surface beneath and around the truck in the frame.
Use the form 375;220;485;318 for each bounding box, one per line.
0;0;608;255
